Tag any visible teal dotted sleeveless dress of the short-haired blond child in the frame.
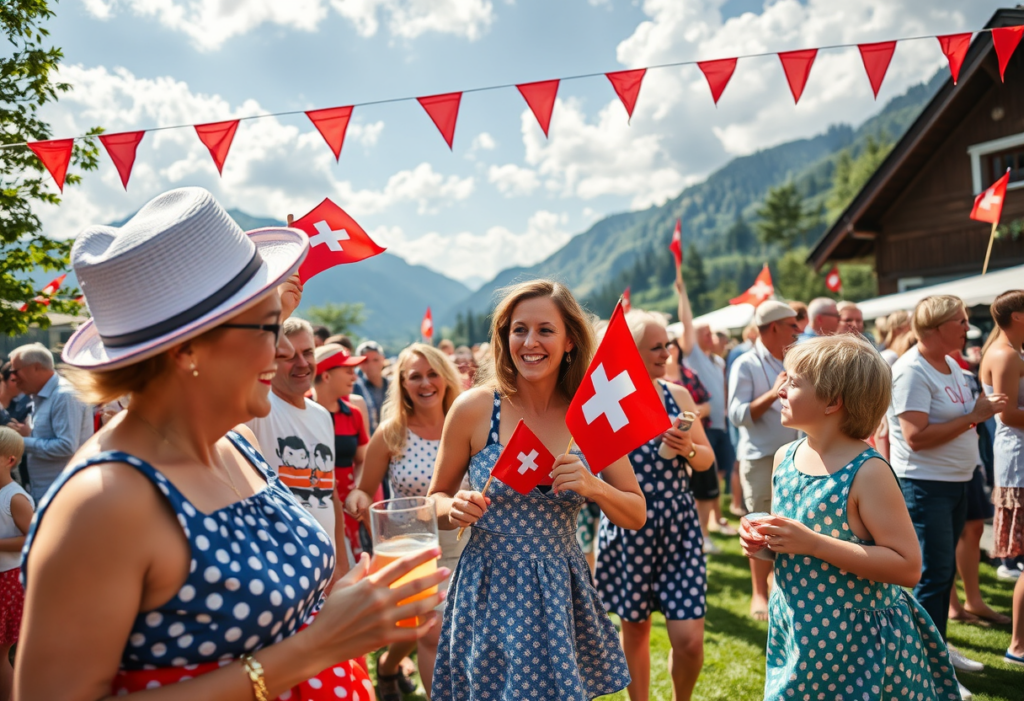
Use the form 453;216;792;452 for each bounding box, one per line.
765;443;961;701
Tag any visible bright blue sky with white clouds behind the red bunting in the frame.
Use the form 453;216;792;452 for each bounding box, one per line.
40;0;999;283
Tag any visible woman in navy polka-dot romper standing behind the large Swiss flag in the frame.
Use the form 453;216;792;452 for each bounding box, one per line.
596;310;715;701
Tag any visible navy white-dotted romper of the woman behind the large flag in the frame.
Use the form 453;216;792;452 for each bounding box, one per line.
596;383;708;622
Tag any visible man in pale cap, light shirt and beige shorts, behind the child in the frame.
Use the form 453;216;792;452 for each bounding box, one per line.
729;300;800;620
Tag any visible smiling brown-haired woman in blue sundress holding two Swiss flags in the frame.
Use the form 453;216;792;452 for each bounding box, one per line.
430;280;645;701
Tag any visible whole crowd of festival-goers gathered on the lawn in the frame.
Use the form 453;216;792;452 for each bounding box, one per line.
0;188;1024;701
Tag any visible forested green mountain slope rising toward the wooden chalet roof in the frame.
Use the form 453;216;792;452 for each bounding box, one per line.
440;72;946;324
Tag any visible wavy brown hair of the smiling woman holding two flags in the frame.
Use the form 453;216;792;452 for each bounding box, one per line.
487;279;595;399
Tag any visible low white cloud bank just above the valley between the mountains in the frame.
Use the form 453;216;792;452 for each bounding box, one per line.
371;210;572;280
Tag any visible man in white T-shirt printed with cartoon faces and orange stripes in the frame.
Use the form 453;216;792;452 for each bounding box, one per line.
248;316;350;576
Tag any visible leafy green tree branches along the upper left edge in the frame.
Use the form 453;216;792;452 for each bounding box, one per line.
0;0;99;336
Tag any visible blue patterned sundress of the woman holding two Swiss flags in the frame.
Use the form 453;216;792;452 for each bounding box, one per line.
431;395;630;701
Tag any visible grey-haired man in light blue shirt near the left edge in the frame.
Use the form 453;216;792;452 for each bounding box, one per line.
9;343;92;503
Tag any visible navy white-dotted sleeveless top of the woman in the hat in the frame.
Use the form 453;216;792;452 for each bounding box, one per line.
23;433;335;670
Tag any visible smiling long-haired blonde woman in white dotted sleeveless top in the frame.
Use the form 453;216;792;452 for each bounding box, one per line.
345;343;469;701
